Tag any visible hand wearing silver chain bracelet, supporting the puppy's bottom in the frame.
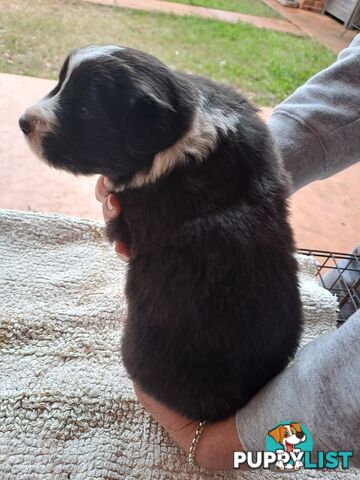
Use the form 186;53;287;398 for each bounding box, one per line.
134;385;243;471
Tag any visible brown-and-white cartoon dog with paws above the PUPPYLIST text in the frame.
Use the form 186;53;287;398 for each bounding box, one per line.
268;422;306;470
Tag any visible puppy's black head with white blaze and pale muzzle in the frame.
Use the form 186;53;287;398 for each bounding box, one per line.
19;46;192;182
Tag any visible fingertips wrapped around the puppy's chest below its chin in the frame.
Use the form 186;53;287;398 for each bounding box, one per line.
95;175;130;262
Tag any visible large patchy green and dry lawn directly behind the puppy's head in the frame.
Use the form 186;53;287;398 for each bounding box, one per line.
0;0;335;106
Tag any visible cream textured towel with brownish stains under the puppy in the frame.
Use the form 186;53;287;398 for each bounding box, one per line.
0;210;356;480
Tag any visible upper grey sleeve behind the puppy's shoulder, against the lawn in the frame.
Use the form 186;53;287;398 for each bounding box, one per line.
268;35;360;193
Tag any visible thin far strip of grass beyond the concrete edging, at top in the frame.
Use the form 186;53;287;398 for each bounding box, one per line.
160;0;281;18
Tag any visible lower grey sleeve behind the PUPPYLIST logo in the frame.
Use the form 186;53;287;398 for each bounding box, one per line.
236;310;360;468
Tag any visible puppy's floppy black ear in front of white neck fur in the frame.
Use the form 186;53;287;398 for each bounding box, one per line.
124;87;179;154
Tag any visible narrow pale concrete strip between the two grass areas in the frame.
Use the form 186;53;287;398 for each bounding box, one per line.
87;0;304;36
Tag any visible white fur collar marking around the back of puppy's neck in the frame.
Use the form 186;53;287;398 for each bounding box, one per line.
114;96;240;192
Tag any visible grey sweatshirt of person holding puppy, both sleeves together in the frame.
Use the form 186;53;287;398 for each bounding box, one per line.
236;35;360;468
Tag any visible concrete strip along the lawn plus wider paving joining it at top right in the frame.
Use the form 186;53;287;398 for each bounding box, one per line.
88;0;357;54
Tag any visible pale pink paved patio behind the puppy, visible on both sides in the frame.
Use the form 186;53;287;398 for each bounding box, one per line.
0;74;360;252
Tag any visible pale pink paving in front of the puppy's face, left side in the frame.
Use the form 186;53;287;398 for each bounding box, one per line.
0;74;102;220
